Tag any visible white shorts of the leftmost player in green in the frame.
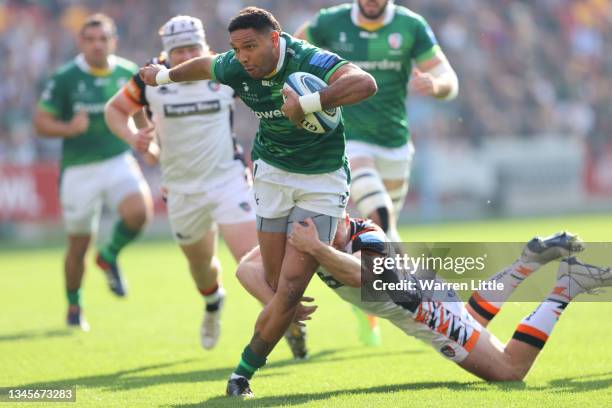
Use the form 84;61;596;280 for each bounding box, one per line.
60;152;151;234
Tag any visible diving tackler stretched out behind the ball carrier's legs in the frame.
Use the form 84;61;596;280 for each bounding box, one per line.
237;215;612;381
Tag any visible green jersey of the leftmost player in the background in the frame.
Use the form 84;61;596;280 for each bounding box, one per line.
38;55;138;169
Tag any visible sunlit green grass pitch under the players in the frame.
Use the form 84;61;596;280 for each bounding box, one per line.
0;215;612;407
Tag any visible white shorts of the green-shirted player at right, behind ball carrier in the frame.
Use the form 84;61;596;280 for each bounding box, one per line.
346;140;414;180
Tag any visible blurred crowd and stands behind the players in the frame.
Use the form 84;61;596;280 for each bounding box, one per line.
0;0;612;242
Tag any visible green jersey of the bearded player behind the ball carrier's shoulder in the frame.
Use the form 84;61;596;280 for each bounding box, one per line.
306;4;438;147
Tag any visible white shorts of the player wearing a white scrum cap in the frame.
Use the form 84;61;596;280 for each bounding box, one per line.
167;164;255;245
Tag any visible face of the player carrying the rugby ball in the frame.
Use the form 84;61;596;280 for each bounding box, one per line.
230;28;279;79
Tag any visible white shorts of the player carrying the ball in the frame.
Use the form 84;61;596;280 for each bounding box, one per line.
253;160;349;218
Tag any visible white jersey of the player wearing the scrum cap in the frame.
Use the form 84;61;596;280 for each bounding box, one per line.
124;55;244;194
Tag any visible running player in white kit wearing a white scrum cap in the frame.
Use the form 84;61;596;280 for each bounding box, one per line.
105;16;257;349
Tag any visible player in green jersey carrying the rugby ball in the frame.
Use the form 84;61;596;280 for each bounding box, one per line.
141;7;376;396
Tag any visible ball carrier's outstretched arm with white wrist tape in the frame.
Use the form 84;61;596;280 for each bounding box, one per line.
140;56;214;86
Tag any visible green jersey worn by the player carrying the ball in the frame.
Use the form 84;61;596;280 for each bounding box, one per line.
211;33;347;174
